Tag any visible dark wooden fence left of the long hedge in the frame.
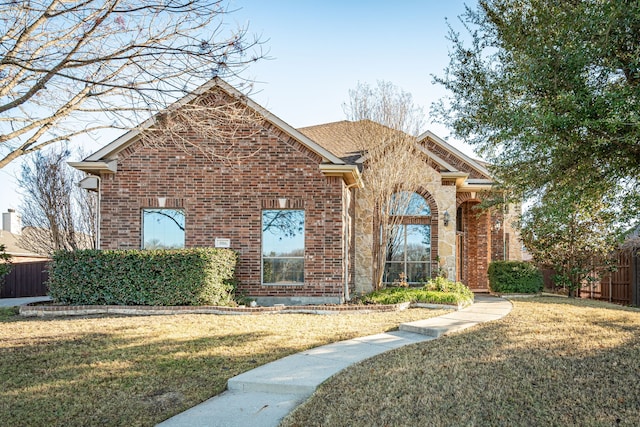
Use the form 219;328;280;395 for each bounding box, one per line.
0;261;49;298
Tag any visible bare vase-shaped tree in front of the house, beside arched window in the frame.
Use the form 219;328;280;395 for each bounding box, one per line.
344;82;430;289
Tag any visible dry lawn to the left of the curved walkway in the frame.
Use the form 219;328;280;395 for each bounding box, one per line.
0;309;443;427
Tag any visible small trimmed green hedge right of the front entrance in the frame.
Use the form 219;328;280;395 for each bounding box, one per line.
489;261;543;294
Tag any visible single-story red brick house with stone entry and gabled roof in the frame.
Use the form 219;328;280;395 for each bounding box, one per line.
71;79;521;305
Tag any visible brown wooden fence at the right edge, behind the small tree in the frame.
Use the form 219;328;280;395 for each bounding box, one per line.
542;247;640;307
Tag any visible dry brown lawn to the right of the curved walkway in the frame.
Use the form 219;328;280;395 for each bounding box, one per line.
283;297;640;427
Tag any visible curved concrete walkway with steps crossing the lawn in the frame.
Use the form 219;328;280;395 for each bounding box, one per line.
159;295;512;427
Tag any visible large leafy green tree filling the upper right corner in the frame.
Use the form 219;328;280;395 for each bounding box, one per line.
434;0;640;214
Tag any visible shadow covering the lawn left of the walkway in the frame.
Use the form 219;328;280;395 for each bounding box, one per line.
0;326;293;426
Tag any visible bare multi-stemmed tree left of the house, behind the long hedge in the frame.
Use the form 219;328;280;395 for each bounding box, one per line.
18;149;97;254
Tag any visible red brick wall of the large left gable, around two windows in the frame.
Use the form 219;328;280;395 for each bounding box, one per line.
101;103;348;297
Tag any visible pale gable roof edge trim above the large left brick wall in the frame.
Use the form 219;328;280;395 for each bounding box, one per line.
69;77;345;173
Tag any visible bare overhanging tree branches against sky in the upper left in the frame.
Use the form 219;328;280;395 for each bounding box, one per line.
0;0;263;168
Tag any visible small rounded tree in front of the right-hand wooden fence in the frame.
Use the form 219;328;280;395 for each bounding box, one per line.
521;193;619;297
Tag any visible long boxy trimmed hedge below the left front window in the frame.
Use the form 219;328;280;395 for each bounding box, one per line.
49;248;237;306
